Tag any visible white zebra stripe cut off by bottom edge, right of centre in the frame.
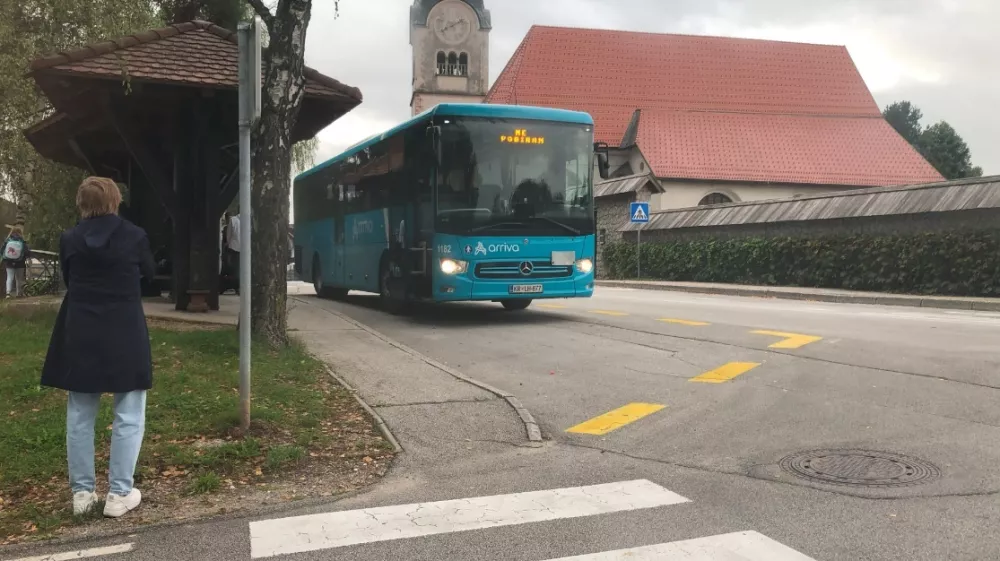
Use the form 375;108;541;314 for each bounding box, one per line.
548;532;816;561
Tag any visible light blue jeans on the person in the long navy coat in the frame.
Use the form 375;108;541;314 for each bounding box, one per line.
66;390;146;497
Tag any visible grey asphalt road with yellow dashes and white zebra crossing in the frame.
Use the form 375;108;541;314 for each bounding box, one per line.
0;288;1000;561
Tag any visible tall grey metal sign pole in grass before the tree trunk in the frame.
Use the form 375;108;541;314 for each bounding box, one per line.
238;23;253;431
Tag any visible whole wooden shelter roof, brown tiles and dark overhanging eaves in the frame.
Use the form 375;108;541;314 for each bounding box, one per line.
25;21;362;169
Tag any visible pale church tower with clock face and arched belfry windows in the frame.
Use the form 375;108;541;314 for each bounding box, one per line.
410;0;492;115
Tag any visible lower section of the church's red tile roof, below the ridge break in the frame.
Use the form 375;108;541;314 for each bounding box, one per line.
636;111;941;186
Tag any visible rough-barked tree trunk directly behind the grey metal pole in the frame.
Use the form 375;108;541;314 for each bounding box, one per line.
250;0;312;347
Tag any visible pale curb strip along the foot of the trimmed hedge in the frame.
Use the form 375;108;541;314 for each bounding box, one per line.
597;281;1000;312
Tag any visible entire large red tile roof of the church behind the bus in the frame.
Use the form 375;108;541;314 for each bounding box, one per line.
486;26;942;186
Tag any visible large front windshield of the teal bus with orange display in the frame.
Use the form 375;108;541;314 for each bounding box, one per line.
436;118;594;236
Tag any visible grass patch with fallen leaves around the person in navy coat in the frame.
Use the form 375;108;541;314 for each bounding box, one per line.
0;304;392;544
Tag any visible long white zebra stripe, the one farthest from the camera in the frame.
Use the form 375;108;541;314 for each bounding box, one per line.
250;479;690;559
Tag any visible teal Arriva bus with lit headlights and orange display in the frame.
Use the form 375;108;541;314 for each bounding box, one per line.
293;104;608;313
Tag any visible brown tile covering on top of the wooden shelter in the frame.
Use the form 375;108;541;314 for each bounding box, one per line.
31;21;361;103
